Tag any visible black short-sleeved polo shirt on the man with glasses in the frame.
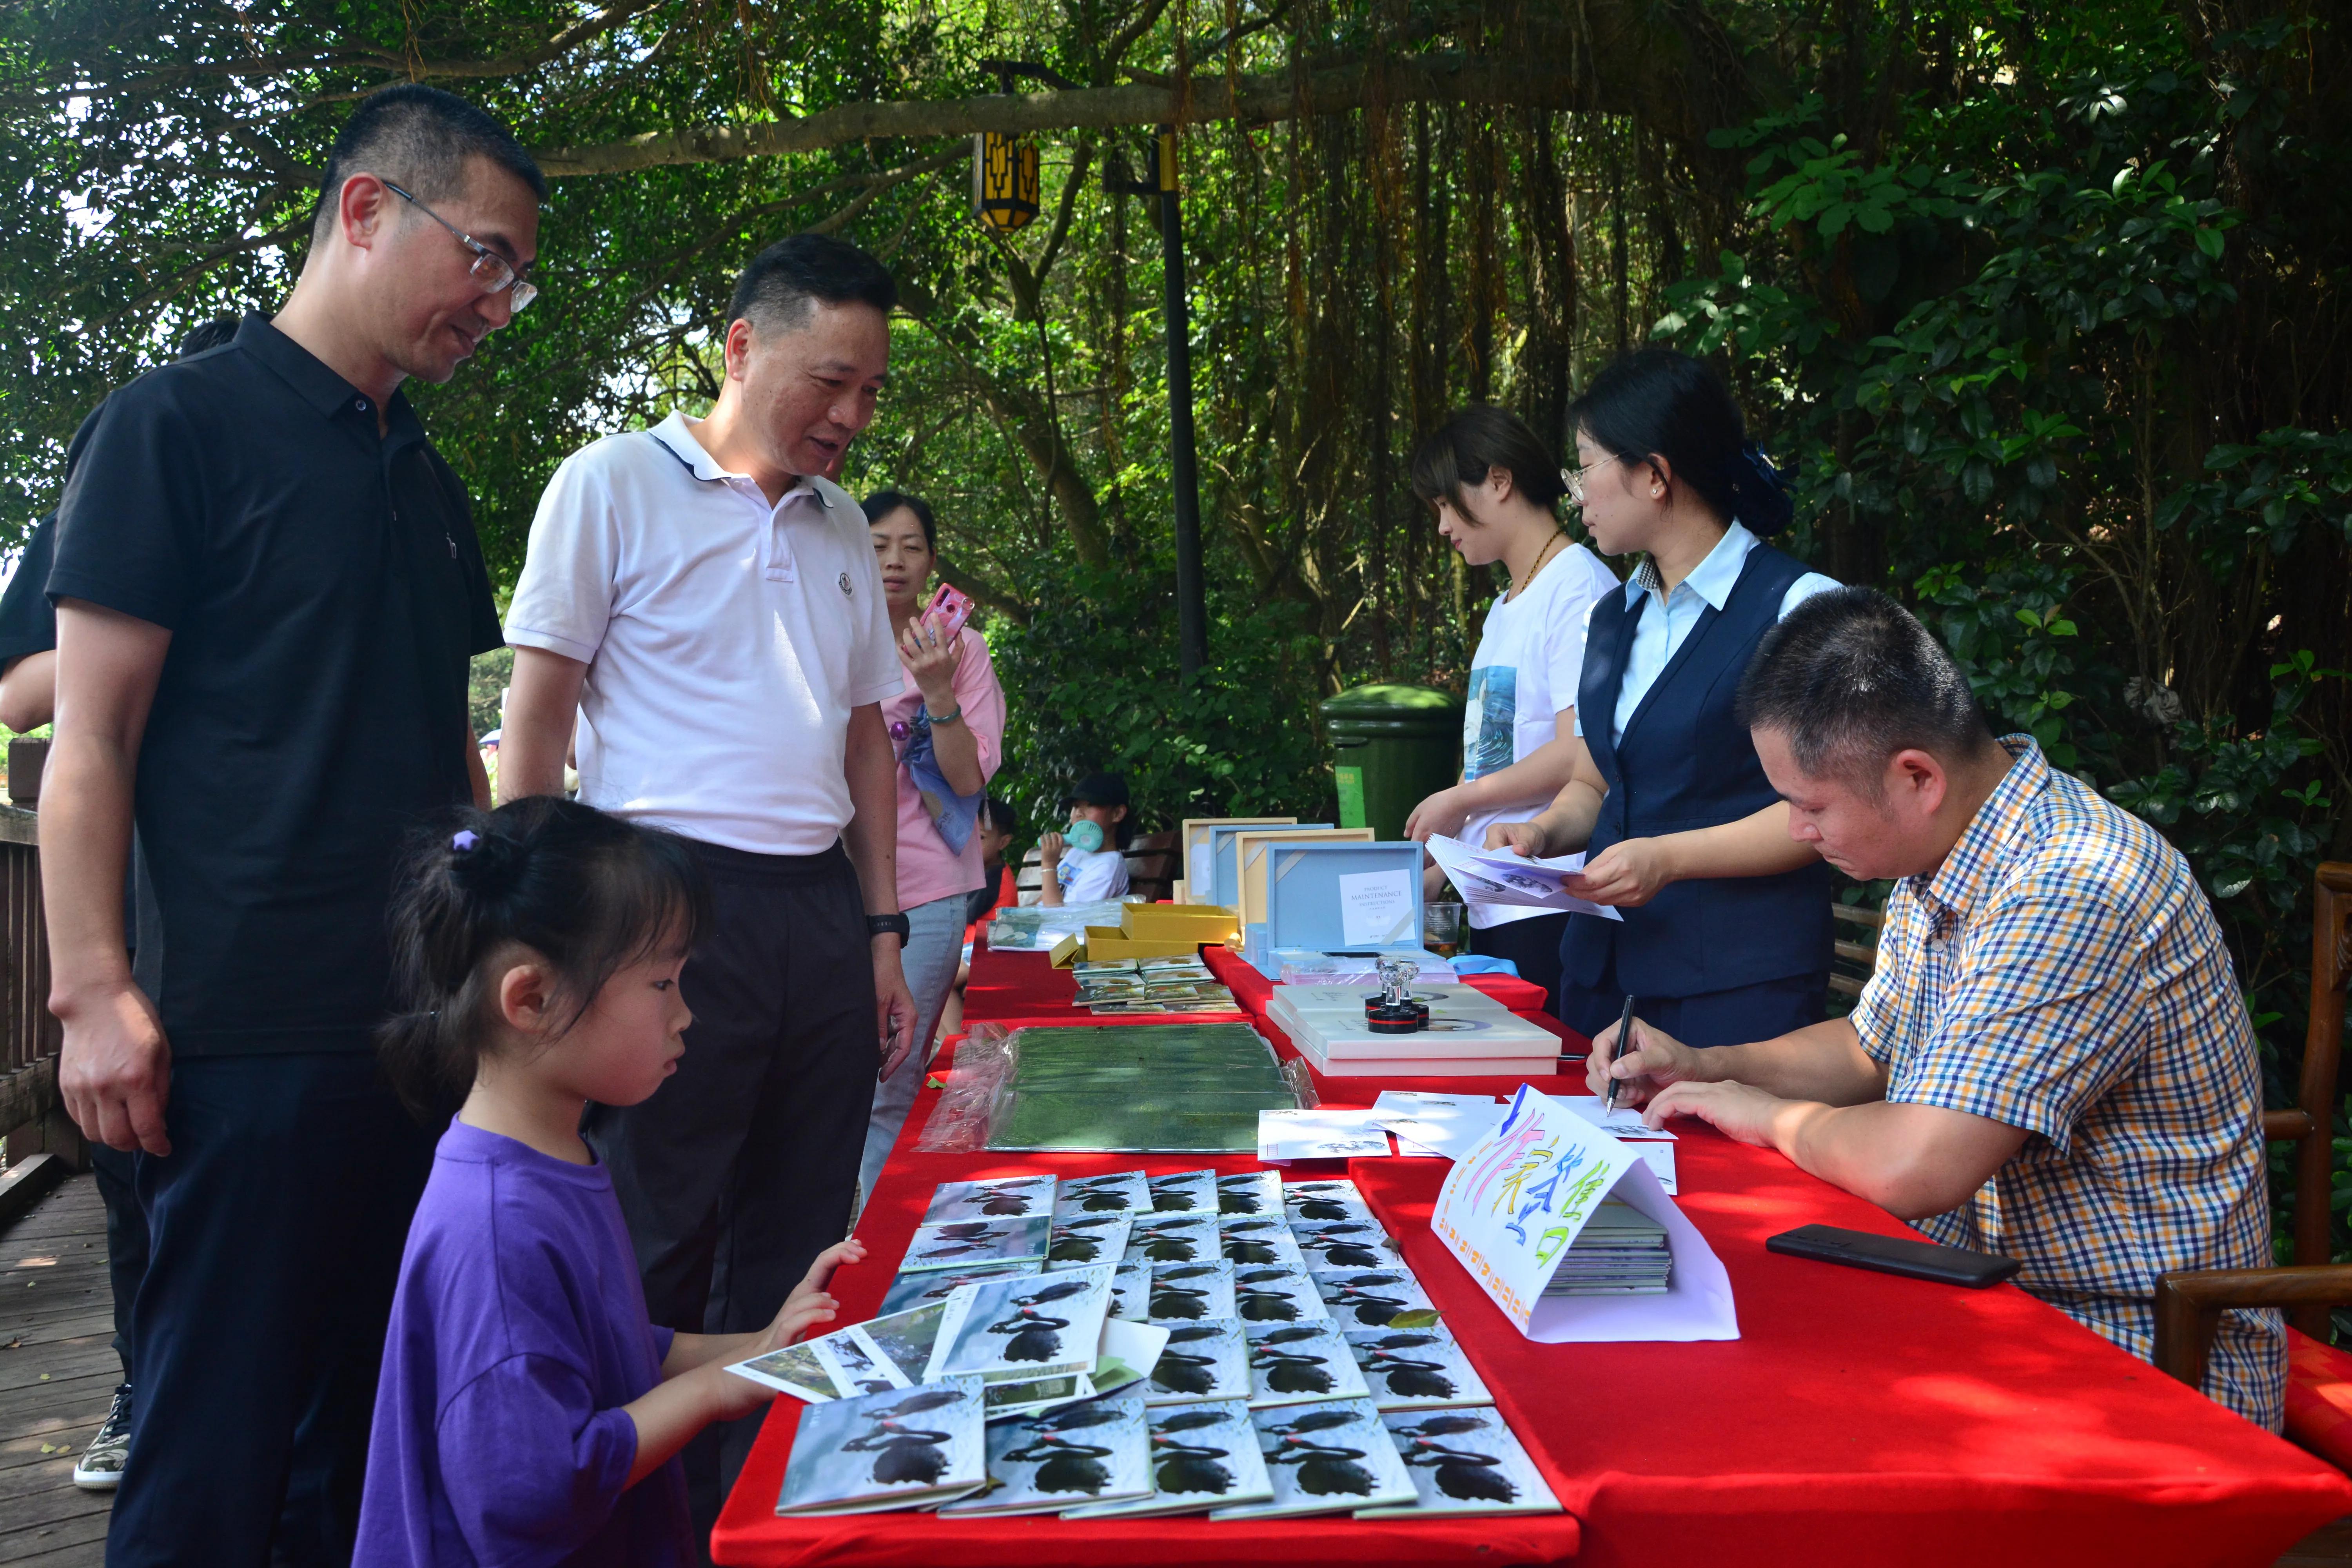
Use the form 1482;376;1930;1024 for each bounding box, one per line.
49;315;499;1056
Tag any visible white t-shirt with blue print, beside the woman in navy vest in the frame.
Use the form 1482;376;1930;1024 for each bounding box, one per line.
1458;545;1618;929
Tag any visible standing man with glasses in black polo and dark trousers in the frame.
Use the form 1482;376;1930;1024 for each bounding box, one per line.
40;85;546;1563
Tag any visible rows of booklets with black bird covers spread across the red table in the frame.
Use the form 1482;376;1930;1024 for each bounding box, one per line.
731;1171;1559;1519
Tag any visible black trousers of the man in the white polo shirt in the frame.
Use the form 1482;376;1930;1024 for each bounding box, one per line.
583;844;882;1542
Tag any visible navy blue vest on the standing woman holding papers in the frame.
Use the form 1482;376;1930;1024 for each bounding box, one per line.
1559;543;1832;997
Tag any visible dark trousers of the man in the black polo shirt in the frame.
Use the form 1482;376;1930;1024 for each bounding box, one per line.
106;1051;435;1568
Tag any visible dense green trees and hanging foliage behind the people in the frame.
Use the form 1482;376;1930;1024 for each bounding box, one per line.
0;0;2352;1250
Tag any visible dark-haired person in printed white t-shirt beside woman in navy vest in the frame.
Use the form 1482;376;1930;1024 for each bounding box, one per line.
1404;407;1618;1011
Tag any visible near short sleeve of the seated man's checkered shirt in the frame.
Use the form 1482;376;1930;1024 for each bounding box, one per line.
1886;875;2145;1154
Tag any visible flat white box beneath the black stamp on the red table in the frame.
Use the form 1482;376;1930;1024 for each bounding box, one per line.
1265;980;1559;1079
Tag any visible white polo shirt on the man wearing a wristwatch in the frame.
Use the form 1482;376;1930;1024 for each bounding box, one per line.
506;414;901;856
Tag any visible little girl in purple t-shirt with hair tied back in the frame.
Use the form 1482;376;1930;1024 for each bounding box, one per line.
355;797;866;1568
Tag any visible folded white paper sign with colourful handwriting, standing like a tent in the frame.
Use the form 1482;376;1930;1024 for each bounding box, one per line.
1430;1084;1740;1345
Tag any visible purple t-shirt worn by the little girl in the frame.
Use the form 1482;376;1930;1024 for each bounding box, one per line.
353;1122;694;1568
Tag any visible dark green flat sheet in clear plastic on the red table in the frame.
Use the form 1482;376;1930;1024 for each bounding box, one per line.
988;1023;1298;1154
